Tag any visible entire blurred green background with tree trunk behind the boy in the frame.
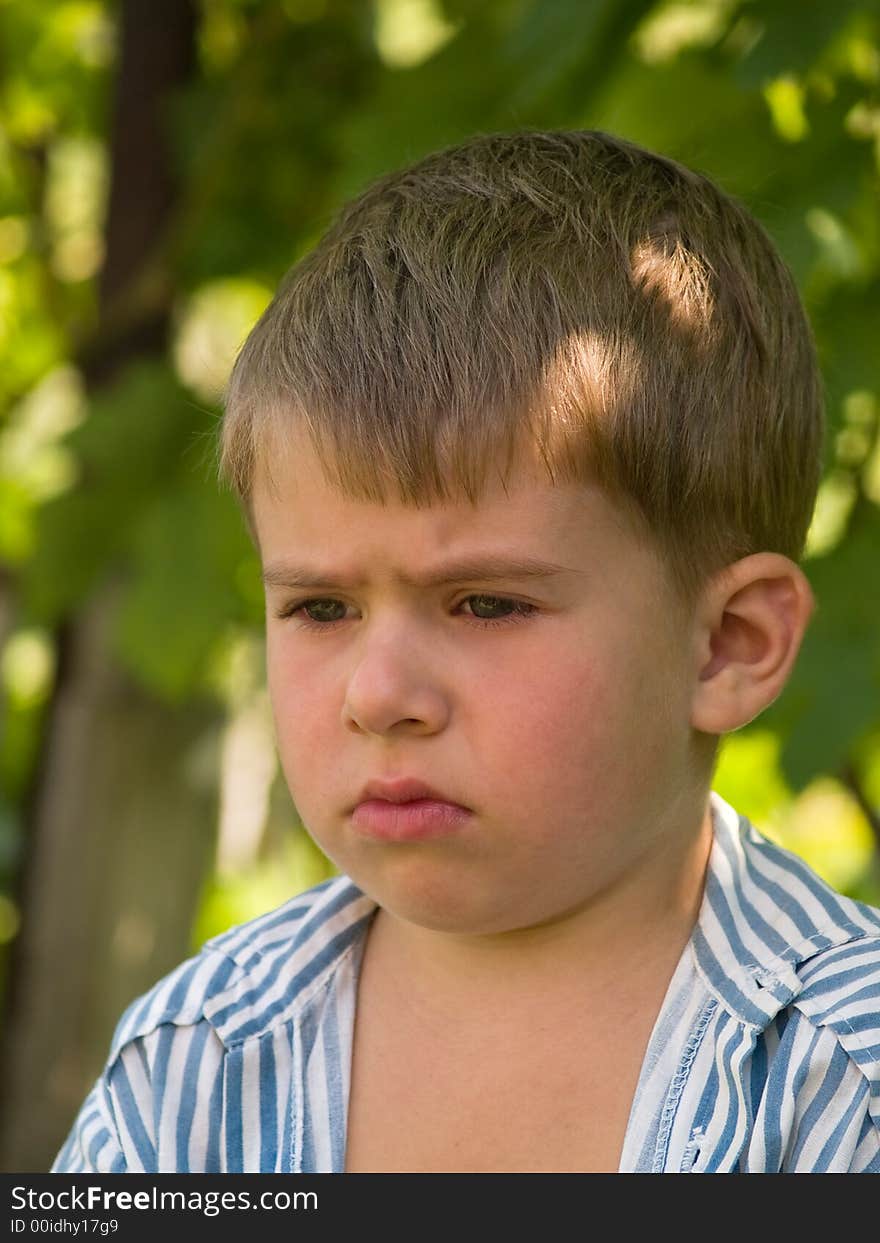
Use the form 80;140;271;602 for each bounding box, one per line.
0;0;880;1168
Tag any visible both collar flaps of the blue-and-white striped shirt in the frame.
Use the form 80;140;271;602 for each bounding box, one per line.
205;792;876;1047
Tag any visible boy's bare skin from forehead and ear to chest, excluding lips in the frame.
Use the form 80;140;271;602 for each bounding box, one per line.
254;440;812;1171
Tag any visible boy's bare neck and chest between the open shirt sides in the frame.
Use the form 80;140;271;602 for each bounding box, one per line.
346;800;711;1173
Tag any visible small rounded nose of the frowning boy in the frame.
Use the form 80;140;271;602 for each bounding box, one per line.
342;628;450;735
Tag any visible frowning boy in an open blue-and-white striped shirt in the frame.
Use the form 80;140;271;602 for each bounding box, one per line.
53;132;880;1172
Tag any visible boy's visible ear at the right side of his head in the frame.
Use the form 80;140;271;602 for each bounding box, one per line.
691;552;814;733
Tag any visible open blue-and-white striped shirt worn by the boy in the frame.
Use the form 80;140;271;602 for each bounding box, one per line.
52;793;880;1173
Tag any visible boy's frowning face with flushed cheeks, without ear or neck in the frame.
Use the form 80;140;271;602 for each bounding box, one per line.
254;427;705;933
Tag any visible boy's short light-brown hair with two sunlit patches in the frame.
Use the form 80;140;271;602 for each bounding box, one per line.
220;131;823;598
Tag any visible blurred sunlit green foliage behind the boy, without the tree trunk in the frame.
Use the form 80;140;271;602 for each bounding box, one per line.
0;0;880;940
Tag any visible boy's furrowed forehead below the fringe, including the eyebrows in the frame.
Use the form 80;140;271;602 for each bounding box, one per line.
252;435;677;628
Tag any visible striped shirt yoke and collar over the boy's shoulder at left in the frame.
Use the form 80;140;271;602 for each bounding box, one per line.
108;876;375;1062
